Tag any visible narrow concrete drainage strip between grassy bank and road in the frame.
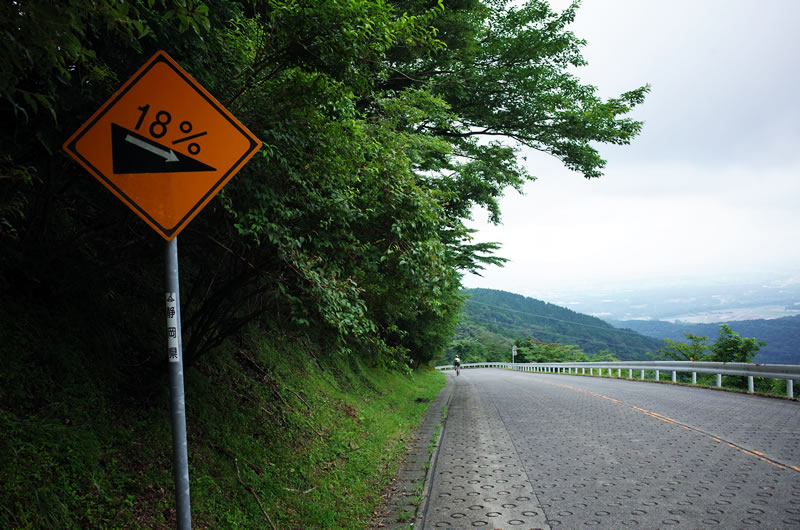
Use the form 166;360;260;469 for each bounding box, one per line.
373;377;455;528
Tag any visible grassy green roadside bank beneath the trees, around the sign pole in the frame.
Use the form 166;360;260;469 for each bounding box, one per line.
0;312;445;528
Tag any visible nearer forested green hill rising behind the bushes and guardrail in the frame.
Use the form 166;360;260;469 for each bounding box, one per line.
455;289;663;360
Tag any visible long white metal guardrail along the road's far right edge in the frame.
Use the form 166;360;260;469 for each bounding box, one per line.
436;361;800;398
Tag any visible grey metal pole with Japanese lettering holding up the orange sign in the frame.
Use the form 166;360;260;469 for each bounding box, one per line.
165;237;192;530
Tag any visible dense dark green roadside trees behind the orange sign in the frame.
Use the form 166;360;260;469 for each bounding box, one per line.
0;0;647;372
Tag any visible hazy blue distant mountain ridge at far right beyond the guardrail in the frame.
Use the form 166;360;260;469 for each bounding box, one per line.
608;316;800;364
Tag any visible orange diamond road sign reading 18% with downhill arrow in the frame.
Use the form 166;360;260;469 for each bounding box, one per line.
64;51;261;241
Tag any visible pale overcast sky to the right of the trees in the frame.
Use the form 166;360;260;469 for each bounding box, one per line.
464;0;800;300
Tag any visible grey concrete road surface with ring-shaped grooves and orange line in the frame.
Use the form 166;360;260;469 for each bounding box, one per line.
423;369;800;529
